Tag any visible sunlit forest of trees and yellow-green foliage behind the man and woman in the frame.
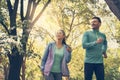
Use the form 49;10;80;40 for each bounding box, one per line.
0;0;120;80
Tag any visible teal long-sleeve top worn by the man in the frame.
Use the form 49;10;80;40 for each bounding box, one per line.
82;30;107;63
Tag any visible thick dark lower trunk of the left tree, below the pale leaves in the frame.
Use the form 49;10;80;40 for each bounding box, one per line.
8;54;23;80
